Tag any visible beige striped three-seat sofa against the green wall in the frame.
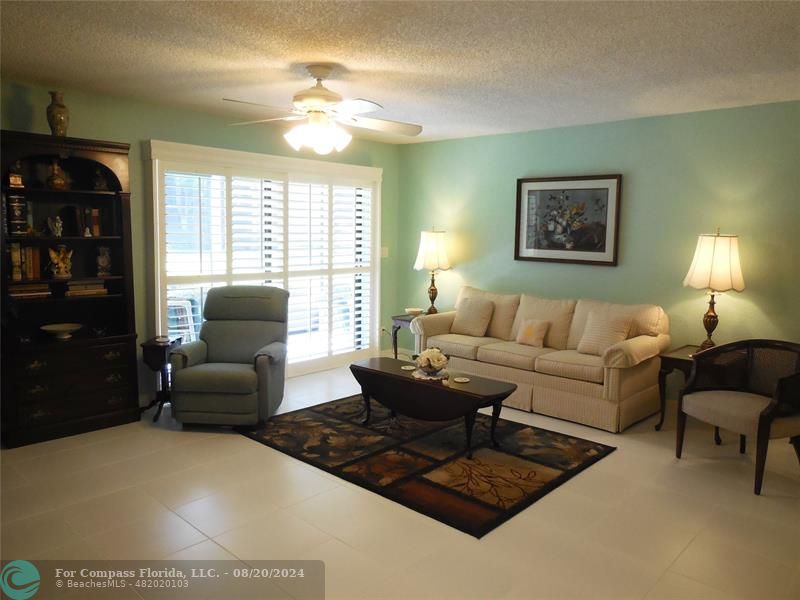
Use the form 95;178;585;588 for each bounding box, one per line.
411;287;670;432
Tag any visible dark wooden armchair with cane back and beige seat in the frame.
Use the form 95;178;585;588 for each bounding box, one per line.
675;340;800;494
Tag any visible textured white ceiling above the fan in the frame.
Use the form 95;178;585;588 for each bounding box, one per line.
0;1;800;142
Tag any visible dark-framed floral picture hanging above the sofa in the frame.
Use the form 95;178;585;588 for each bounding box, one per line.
514;174;622;267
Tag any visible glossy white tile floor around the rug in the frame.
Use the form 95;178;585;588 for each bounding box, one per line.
0;369;800;600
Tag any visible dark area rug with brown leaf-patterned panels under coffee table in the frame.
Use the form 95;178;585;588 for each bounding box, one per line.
245;395;616;538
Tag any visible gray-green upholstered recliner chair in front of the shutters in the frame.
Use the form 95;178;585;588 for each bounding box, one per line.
170;285;289;425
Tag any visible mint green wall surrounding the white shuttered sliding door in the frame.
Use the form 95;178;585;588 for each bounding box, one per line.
0;81;400;394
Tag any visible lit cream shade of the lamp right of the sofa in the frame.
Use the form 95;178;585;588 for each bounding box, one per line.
683;233;744;292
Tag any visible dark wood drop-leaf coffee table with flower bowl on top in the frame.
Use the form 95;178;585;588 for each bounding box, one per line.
350;358;517;458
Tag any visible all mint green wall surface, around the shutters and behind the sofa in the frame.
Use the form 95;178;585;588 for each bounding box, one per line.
0;81;800;370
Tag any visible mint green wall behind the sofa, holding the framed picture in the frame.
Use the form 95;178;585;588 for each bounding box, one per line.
397;102;800;344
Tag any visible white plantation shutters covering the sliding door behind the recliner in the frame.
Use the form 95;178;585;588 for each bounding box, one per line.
157;145;377;368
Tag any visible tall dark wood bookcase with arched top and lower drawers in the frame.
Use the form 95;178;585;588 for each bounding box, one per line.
0;131;139;447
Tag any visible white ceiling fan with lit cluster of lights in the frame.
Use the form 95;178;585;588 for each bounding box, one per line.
223;64;422;154
